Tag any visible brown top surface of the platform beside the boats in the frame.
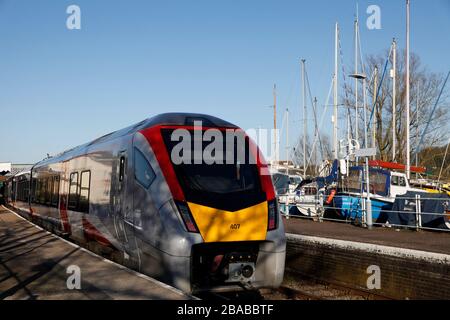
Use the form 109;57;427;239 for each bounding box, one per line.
283;217;450;254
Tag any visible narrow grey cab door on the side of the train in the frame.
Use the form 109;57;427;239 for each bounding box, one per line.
114;151;139;267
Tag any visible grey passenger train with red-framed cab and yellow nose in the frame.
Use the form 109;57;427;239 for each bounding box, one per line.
5;113;286;293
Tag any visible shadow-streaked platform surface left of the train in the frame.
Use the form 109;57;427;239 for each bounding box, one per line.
0;206;192;300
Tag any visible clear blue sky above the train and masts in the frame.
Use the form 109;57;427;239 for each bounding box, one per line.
0;0;450;163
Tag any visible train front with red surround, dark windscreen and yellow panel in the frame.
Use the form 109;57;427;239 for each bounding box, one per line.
142;117;286;292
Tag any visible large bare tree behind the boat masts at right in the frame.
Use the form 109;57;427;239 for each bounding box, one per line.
342;51;450;164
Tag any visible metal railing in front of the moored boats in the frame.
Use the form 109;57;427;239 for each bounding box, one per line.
279;194;450;232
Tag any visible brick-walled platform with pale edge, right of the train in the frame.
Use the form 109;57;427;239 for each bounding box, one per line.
283;218;450;299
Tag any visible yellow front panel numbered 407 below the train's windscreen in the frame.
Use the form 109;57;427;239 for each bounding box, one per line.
188;202;268;242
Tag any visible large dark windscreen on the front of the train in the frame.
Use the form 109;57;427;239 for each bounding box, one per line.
161;129;265;210
